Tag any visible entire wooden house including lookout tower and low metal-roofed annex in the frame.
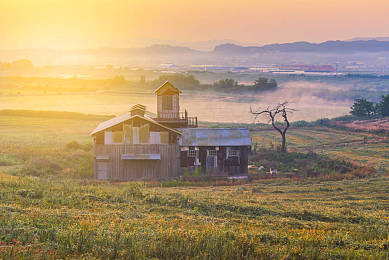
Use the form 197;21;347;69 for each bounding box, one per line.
91;82;251;181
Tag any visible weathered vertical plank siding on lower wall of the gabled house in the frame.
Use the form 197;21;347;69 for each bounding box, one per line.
95;144;180;181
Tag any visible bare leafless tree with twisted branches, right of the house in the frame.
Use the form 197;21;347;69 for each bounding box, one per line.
250;101;295;152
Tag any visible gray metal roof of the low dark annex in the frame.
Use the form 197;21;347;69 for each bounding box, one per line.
178;128;251;146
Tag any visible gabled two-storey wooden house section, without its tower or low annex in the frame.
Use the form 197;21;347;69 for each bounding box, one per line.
92;105;181;181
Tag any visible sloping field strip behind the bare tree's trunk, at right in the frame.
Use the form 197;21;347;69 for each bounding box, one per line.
252;127;389;170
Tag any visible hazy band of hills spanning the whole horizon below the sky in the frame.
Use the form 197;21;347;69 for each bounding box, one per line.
0;40;389;68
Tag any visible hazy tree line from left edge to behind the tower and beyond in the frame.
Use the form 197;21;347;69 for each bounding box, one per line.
0;72;278;92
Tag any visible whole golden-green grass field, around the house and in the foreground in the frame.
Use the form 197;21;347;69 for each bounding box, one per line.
0;113;389;259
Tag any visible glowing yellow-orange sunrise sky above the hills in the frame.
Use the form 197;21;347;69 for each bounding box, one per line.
0;0;389;49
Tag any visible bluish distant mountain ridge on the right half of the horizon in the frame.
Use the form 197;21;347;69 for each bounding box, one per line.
214;40;389;55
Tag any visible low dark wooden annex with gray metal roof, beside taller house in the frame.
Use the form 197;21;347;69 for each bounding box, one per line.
178;128;251;177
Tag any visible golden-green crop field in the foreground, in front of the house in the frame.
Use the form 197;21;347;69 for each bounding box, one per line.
0;174;389;259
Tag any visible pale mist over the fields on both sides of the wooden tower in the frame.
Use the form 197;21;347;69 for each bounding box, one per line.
0;81;352;123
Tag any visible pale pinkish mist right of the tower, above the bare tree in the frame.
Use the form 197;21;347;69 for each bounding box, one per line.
182;82;352;123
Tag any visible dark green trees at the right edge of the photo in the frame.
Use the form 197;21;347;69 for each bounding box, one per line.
350;94;389;118
